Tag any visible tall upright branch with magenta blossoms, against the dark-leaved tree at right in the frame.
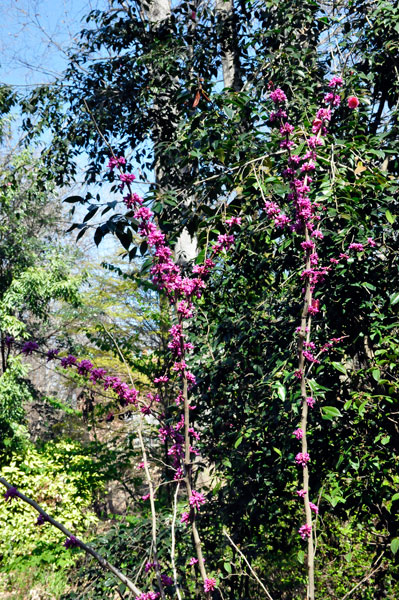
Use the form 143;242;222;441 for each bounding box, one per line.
264;76;376;600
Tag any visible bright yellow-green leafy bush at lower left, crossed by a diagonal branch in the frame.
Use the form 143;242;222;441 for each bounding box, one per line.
0;441;102;595
